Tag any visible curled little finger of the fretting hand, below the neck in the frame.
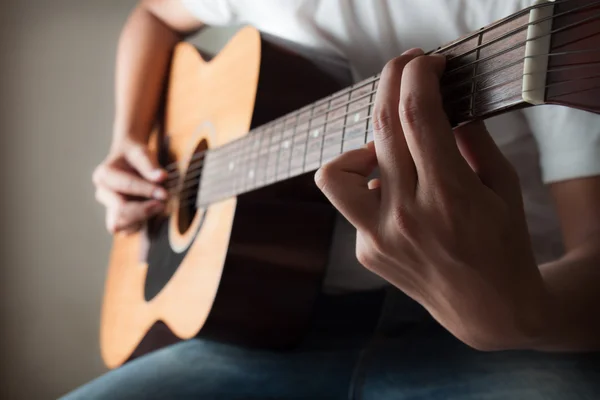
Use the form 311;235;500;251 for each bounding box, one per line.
315;143;379;231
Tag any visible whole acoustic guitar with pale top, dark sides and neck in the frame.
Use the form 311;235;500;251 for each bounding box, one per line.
101;0;600;368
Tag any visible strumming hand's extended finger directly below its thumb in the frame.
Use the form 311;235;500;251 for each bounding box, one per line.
98;167;167;200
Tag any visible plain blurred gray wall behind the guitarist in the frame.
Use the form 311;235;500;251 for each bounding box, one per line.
0;0;234;399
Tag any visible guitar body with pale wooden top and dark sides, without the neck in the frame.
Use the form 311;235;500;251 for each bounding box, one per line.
101;27;350;368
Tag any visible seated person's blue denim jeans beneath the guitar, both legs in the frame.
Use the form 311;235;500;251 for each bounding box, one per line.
64;292;600;400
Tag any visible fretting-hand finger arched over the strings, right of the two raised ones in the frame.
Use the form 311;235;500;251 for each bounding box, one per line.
400;56;473;183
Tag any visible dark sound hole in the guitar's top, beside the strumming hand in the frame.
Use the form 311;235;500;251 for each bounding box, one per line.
177;139;208;234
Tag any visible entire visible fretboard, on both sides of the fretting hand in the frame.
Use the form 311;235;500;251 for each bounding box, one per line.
196;0;560;207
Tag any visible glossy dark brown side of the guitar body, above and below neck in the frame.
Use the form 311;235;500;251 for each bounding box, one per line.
129;35;352;360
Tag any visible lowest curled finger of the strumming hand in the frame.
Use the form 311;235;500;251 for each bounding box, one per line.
107;200;165;233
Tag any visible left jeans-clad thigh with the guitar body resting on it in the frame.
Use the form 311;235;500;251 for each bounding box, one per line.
65;328;368;400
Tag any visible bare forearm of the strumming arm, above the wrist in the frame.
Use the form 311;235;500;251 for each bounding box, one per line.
113;3;202;147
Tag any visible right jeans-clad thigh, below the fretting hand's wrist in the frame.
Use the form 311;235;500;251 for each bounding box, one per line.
358;326;600;400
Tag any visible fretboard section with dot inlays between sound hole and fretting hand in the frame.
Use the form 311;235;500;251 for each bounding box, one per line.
198;77;379;205
